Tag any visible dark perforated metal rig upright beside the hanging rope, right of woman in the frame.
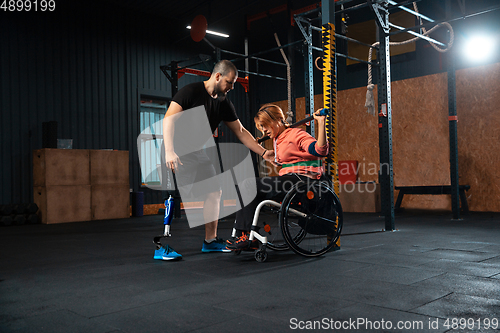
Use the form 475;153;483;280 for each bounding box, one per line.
371;1;395;231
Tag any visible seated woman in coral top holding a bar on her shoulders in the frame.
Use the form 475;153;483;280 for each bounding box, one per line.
227;104;329;250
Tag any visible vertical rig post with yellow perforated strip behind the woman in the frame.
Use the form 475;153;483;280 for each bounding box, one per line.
321;0;339;194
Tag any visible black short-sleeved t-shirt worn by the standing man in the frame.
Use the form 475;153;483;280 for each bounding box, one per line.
173;82;238;132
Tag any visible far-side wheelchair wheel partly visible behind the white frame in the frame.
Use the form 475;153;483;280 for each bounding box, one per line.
258;207;288;251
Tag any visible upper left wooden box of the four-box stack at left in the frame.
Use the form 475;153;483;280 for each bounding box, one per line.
33;148;90;186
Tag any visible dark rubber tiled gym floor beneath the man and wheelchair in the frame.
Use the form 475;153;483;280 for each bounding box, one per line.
0;211;500;333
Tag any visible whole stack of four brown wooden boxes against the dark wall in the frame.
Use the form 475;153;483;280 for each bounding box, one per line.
33;149;130;224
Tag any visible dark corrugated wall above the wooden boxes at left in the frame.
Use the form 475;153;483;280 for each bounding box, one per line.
0;2;199;204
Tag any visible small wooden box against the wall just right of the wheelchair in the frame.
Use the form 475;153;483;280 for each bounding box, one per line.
339;183;381;213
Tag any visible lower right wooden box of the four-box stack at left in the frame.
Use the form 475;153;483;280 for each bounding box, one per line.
91;183;130;220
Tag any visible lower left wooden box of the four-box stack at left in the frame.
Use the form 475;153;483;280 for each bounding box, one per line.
33;185;91;224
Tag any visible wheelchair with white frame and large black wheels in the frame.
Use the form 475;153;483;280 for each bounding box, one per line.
233;180;343;262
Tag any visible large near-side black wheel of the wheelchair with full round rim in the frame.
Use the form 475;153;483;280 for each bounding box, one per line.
280;181;343;257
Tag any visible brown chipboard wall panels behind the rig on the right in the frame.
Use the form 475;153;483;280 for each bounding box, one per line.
277;63;500;212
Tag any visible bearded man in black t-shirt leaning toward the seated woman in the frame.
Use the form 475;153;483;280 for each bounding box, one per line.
163;60;274;252
